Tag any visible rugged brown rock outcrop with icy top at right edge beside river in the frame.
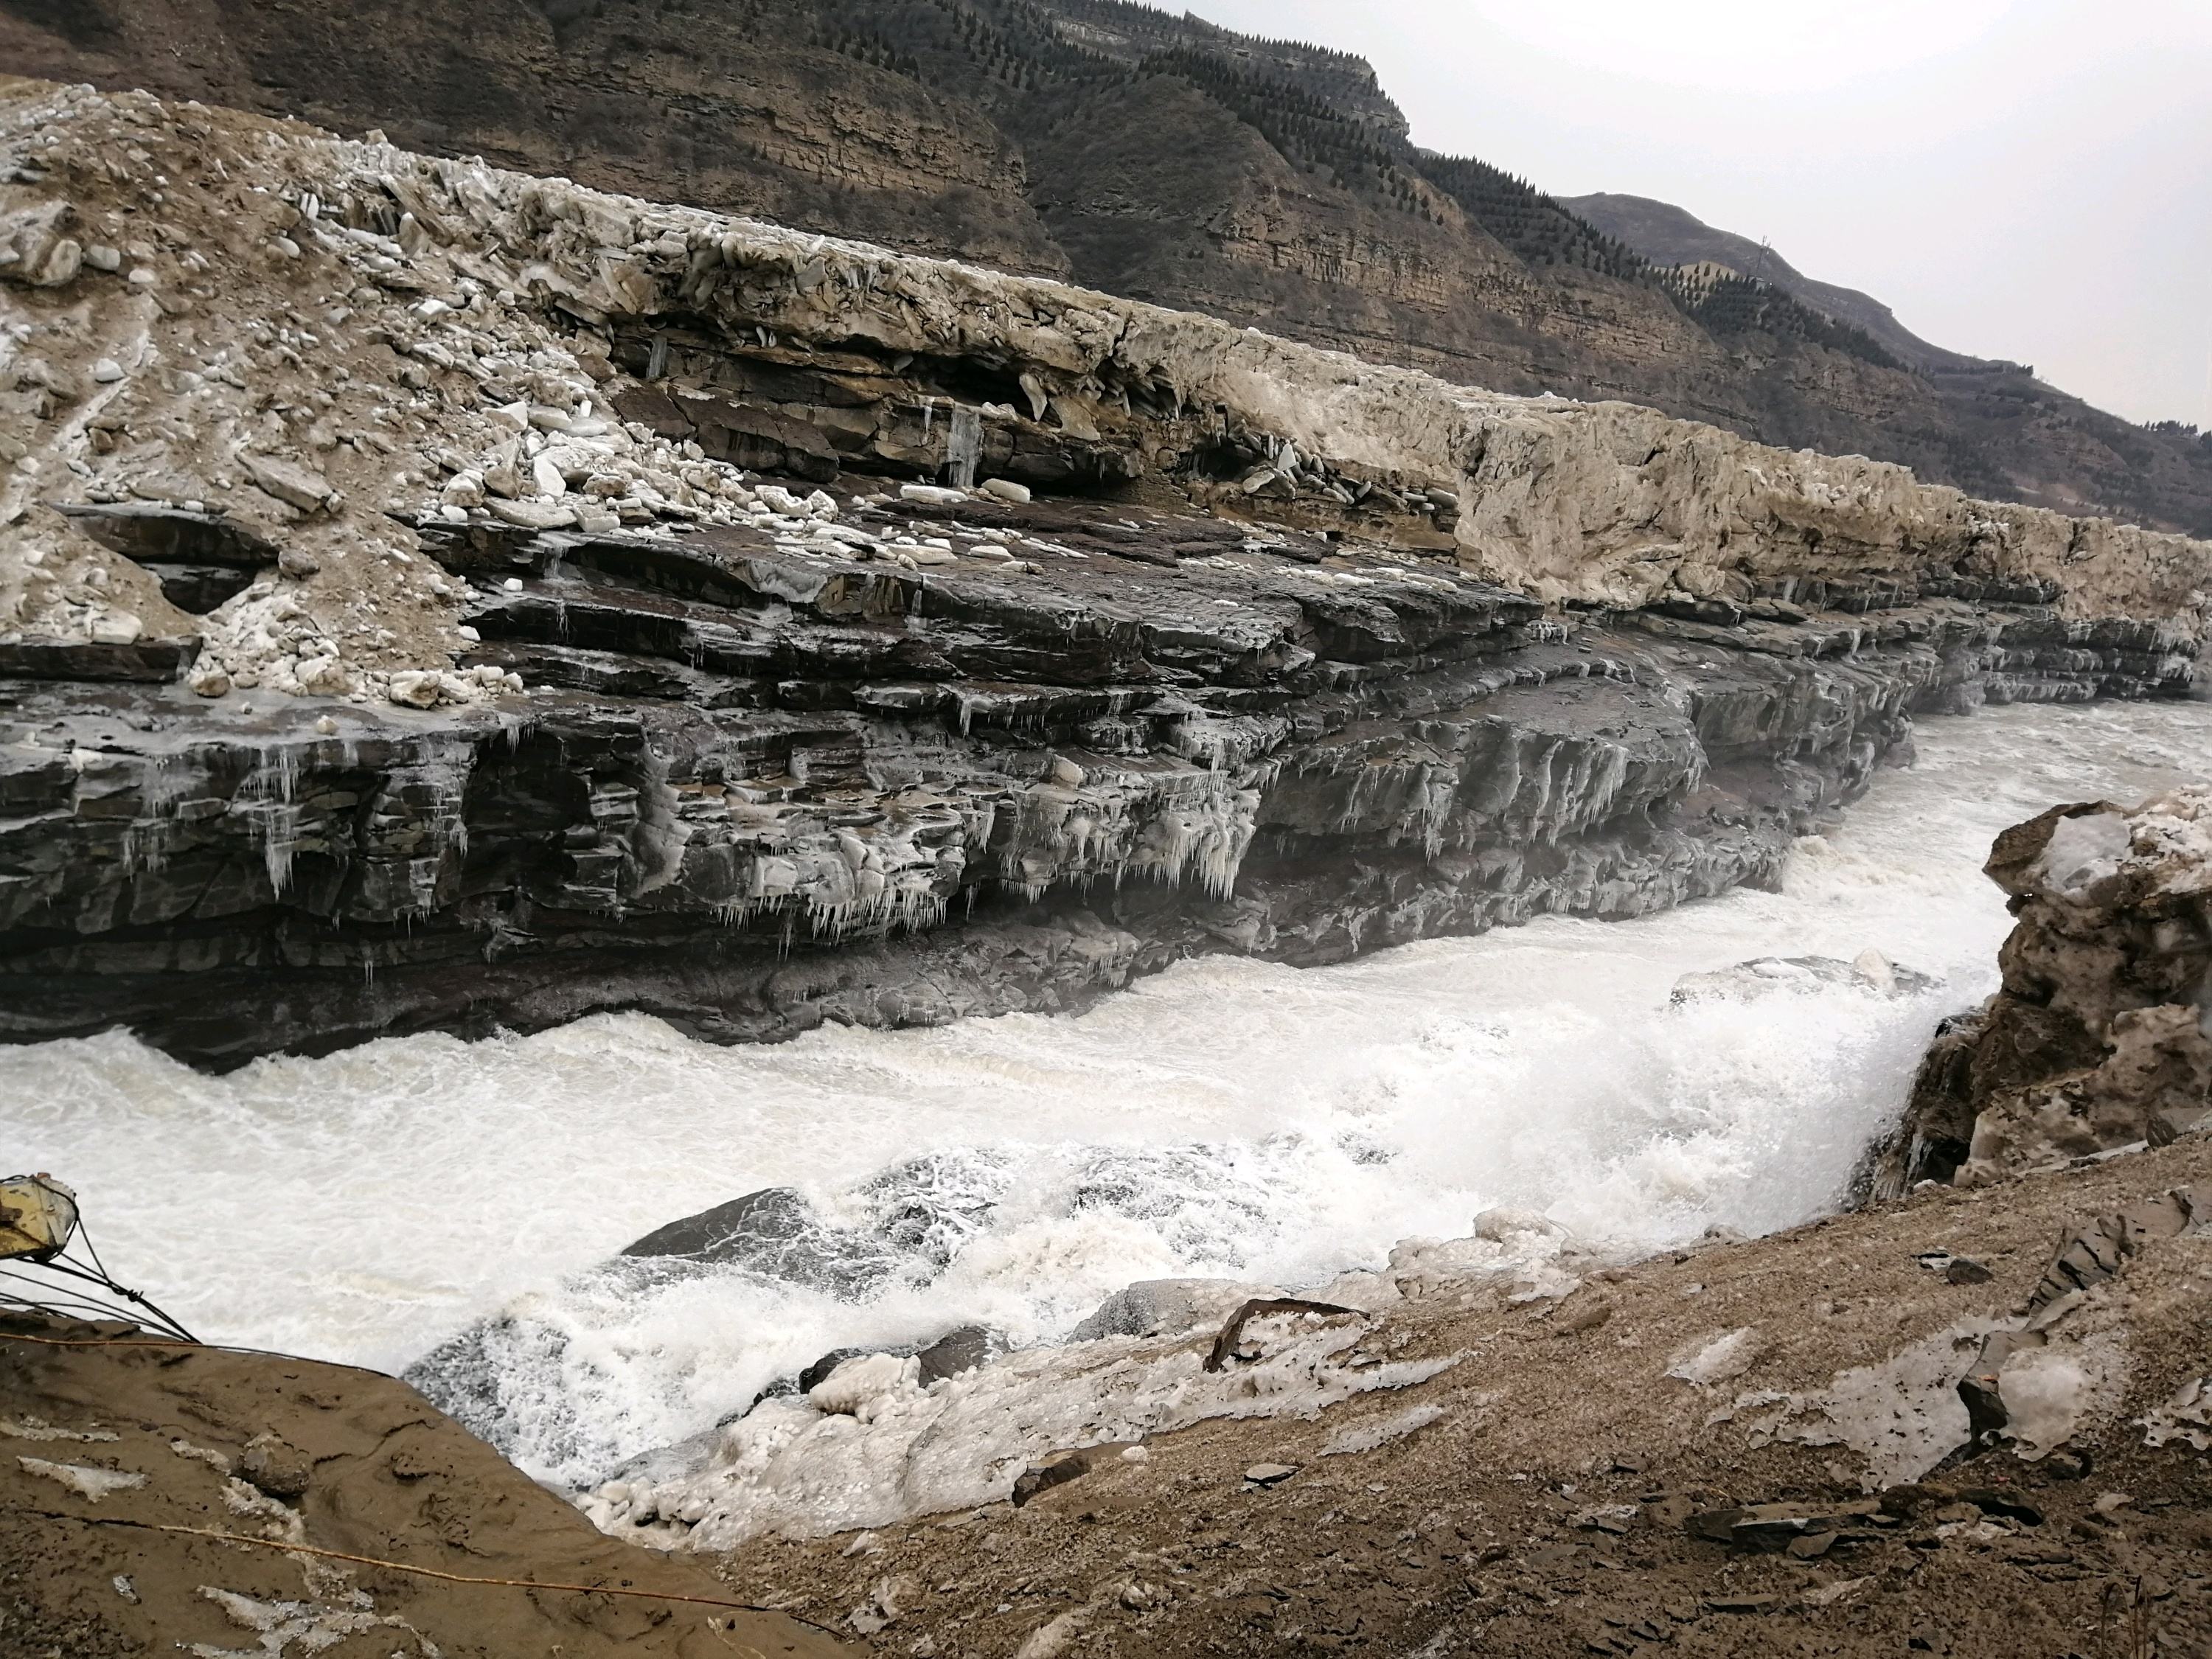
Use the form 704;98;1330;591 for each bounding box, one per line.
1874;790;2212;1197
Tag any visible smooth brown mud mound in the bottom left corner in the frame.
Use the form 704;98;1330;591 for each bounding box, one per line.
0;1318;845;1659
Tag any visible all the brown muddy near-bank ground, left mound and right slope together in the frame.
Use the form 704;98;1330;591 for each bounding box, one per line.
0;1135;2212;1659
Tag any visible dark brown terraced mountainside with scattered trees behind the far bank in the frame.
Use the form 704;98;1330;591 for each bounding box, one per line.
0;0;2212;533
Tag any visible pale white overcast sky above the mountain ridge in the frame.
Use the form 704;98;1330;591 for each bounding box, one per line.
1170;0;2212;429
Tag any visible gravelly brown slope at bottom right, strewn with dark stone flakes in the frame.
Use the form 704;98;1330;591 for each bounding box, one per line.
723;1139;2212;1659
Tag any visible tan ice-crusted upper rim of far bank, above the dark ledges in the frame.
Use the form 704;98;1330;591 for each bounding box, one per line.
15;73;2212;641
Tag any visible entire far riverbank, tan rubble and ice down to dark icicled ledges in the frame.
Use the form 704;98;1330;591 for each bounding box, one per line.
0;82;2208;1066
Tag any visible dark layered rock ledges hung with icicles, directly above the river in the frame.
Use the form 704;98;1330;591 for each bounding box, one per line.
0;522;2194;1066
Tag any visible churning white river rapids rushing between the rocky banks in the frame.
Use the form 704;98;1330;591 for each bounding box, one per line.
0;703;2212;1484
